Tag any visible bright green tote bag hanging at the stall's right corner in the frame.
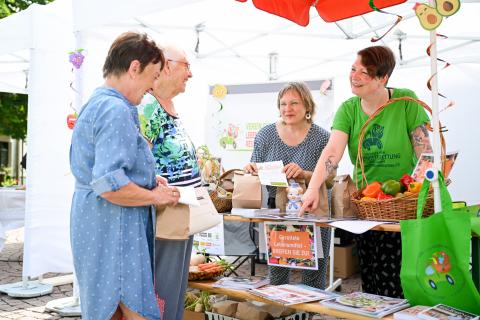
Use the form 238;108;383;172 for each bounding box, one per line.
400;173;480;314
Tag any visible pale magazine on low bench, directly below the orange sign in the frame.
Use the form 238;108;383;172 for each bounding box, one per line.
249;284;332;305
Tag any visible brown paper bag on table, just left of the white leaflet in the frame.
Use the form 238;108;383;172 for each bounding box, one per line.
232;171;262;209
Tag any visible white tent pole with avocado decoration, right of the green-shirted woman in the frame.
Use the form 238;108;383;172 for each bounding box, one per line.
429;0;442;212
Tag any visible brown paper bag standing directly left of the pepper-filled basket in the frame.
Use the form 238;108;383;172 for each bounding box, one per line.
332;174;358;218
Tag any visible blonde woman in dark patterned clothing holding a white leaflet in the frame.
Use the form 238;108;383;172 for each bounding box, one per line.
245;82;330;289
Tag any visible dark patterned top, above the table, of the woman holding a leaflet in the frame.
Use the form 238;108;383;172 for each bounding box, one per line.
250;123;330;197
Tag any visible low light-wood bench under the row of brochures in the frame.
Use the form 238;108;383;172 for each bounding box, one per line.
188;281;393;320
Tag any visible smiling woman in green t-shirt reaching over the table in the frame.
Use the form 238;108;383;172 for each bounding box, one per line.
301;46;432;297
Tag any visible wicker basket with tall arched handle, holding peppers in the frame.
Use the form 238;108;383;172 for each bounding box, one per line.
351;97;445;221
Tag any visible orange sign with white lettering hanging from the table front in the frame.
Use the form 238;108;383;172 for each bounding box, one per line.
265;222;323;270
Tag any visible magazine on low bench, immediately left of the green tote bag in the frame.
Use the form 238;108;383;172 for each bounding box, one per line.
321;292;409;318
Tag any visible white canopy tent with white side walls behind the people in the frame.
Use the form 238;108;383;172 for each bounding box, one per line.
0;0;480;276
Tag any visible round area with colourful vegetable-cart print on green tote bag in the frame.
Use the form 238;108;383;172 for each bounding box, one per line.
417;246;465;299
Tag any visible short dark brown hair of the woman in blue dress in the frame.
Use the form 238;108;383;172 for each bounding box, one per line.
103;32;165;78
